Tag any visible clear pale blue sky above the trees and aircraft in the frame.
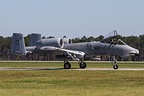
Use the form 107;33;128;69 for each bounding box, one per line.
0;0;144;38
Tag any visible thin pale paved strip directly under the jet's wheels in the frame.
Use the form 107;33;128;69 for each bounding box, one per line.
0;68;144;71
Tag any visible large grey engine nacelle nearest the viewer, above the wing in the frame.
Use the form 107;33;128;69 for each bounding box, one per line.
36;38;64;49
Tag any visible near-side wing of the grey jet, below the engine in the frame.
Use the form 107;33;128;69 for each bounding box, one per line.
40;46;85;57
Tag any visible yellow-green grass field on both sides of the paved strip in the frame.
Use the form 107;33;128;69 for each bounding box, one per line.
0;62;144;96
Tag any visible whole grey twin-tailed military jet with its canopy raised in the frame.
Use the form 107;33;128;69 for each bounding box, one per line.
11;30;139;69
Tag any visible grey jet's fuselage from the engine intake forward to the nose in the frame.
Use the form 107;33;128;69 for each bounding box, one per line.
64;42;138;56
